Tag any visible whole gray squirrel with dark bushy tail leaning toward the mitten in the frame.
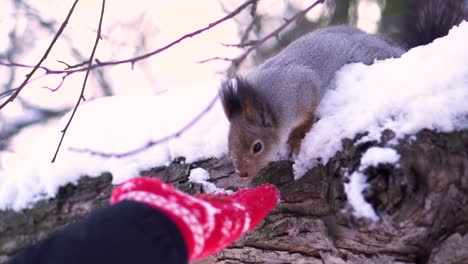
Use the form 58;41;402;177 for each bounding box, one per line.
219;0;463;177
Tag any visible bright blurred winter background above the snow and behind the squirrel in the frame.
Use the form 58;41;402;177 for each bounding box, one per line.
0;0;411;168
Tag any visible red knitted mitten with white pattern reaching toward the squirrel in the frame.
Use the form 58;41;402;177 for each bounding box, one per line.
111;177;279;260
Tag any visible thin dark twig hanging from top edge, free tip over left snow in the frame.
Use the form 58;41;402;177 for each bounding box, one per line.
52;0;106;163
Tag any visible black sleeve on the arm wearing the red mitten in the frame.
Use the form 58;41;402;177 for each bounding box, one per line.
9;202;188;264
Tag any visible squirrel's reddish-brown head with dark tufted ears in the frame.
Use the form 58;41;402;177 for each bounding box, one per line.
220;77;280;177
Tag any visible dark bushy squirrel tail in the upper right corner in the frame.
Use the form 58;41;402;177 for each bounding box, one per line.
401;0;468;49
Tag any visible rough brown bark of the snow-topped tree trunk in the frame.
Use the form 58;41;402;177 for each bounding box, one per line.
0;131;468;264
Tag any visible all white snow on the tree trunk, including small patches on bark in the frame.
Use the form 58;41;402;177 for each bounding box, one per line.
0;22;468;213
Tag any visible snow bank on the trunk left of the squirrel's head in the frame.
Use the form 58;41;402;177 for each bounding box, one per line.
0;84;229;210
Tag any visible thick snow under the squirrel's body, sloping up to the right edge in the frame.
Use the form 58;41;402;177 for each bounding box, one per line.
294;21;468;178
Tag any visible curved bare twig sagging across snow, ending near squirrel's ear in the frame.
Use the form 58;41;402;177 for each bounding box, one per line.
68;95;218;158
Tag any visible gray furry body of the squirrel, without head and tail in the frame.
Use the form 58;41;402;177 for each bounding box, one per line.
245;26;405;138
